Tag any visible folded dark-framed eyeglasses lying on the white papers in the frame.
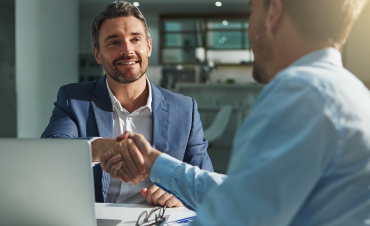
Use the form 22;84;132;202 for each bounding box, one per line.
136;205;167;226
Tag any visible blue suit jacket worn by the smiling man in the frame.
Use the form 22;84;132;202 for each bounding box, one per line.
41;76;213;202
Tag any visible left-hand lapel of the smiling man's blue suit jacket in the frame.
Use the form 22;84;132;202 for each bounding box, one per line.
91;75;113;138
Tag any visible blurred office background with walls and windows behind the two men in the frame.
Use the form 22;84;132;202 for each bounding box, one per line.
0;0;370;173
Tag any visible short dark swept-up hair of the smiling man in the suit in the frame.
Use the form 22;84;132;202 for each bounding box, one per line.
91;1;150;51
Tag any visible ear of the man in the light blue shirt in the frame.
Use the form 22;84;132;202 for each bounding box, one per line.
266;0;284;35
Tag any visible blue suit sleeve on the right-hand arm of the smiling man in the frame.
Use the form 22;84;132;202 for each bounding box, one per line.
184;99;213;172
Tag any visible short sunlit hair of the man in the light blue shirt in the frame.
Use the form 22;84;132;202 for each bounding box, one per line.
265;0;367;47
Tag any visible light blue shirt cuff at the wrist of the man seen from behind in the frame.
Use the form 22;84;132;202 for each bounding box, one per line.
150;153;183;190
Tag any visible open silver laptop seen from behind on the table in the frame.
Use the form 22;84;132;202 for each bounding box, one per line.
0;138;120;226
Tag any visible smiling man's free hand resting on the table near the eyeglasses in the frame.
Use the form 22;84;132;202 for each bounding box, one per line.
141;185;184;208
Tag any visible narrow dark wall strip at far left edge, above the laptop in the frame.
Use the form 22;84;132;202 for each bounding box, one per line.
0;1;17;137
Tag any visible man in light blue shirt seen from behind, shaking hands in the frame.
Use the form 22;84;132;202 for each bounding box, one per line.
101;0;370;226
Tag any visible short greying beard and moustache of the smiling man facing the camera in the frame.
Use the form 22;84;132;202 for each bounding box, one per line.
103;56;148;83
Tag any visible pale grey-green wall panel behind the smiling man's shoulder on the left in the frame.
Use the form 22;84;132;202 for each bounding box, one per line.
15;0;79;138
